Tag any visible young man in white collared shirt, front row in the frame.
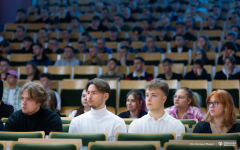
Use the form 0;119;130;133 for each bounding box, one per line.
128;78;185;136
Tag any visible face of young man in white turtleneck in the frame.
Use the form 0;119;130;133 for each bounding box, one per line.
87;84;109;110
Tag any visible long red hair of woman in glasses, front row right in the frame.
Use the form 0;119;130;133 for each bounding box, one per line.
206;90;237;129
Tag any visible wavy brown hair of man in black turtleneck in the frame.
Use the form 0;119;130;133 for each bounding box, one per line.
18;82;50;104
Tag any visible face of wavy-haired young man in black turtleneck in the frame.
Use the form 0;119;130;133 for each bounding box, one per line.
21;91;41;115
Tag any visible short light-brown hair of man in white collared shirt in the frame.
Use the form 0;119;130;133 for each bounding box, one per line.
146;78;169;96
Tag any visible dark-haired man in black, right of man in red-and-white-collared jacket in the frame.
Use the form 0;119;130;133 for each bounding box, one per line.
157;58;183;81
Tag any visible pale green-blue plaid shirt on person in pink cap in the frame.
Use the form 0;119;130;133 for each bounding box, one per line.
2;86;22;110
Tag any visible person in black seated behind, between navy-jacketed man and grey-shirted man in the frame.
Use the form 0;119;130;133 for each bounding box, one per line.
44;38;64;54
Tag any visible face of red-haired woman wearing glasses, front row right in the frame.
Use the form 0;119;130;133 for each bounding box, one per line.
208;96;225;118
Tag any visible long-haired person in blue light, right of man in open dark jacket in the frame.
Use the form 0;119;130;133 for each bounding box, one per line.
195;34;216;52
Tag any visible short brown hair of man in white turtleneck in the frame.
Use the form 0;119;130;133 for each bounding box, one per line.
85;78;111;95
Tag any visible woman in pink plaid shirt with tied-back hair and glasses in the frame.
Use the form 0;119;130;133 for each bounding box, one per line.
165;87;205;122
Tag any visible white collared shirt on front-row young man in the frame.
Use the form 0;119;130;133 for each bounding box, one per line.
128;112;185;136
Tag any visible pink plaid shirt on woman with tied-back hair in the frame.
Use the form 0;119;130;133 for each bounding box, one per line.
165;105;205;122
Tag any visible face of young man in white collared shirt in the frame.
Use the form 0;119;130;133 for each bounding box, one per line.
146;89;167;111
